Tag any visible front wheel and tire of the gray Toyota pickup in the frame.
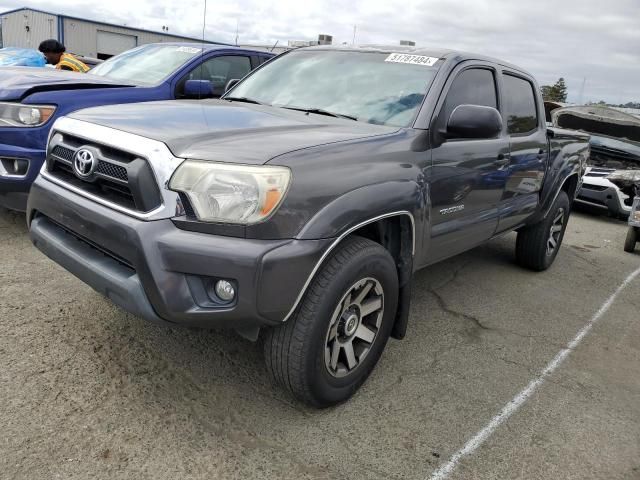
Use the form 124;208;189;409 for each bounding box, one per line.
264;236;398;408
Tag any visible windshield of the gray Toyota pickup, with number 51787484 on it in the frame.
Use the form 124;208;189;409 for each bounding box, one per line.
228;50;437;127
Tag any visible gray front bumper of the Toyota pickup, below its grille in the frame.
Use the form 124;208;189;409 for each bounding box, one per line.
27;177;331;330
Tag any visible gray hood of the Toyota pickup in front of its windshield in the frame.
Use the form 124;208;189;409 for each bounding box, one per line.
71;100;399;164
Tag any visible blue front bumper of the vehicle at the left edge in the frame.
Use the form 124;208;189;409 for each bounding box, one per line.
0;143;45;211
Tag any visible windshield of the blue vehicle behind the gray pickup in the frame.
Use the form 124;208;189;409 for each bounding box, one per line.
91;44;202;85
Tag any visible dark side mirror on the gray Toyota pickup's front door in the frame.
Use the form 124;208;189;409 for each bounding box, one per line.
447;105;502;139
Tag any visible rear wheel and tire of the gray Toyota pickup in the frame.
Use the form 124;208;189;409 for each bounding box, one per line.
516;191;571;272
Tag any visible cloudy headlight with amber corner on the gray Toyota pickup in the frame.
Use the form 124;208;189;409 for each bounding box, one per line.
169;160;291;225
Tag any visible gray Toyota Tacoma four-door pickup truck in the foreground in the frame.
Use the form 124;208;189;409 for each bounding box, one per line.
27;47;589;407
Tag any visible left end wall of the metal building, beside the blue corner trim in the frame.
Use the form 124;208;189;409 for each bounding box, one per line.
1;10;58;48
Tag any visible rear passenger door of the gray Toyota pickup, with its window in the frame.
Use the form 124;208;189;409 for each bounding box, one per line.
498;70;549;231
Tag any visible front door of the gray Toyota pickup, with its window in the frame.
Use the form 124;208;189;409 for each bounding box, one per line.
425;62;509;263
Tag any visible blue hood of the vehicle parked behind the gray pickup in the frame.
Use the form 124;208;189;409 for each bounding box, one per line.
0;67;132;100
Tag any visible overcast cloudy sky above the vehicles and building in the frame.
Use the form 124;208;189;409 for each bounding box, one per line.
0;0;640;104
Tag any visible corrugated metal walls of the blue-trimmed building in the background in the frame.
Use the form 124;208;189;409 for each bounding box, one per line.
0;9;215;57
